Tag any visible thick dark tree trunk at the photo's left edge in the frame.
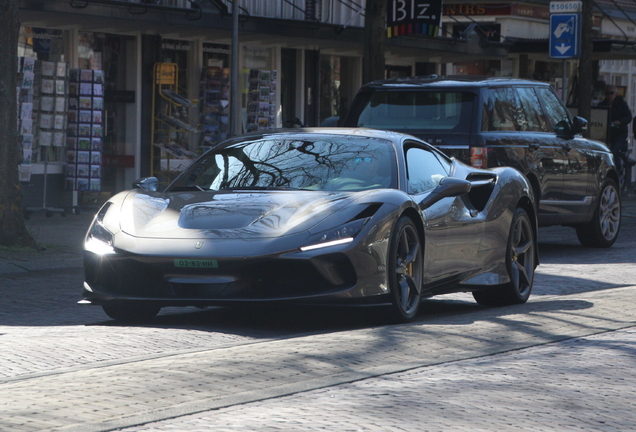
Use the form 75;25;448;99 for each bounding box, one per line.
0;0;36;248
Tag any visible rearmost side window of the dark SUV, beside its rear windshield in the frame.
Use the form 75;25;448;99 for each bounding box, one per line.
481;87;528;132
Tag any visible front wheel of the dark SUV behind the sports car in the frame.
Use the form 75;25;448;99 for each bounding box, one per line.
576;179;621;248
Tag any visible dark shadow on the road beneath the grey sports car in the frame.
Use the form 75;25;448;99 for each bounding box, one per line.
90;297;593;339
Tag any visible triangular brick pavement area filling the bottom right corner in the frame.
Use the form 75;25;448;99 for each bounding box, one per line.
122;327;636;432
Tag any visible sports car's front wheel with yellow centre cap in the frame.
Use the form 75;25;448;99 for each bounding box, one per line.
387;216;424;322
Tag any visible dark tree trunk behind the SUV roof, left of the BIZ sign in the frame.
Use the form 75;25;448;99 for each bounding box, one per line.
362;0;387;84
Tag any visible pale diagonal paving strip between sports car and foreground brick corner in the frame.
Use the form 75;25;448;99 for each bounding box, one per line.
0;286;636;432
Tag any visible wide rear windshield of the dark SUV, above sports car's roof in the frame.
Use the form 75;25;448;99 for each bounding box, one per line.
347;88;475;132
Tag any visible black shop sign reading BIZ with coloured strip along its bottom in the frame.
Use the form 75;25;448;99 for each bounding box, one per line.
386;0;442;37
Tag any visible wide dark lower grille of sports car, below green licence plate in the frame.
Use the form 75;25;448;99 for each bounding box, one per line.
87;254;356;300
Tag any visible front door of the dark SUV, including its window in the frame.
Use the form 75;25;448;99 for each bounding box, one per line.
537;87;595;221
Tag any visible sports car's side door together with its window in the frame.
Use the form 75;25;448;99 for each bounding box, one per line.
405;143;484;284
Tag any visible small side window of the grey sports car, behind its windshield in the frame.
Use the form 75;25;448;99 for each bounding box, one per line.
406;147;450;194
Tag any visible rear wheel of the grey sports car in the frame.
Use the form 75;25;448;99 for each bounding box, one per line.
473;207;537;306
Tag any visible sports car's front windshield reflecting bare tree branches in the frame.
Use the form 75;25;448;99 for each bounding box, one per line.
167;134;397;191
